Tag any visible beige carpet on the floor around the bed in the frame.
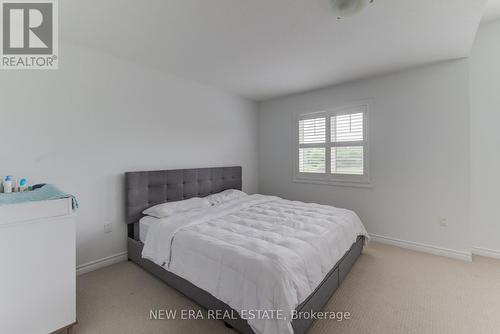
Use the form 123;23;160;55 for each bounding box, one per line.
68;243;500;334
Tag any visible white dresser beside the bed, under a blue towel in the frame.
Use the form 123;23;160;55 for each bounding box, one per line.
0;198;76;334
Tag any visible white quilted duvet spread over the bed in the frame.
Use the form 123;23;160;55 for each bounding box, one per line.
142;195;368;334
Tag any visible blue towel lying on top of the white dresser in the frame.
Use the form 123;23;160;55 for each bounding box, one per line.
0;184;78;210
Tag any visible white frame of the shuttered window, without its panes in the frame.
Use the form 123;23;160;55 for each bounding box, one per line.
293;100;371;187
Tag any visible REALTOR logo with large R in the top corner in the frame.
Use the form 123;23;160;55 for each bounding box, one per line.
0;0;58;69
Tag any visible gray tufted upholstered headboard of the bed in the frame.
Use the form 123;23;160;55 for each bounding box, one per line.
125;167;241;234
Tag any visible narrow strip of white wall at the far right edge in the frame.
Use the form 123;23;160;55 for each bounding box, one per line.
470;21;500;257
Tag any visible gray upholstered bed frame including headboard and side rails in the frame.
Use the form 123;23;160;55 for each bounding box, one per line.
125;167;364;334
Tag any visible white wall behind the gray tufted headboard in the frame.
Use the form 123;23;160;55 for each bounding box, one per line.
0;46;258;264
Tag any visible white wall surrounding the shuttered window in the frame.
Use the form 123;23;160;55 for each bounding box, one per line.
259;60;471;258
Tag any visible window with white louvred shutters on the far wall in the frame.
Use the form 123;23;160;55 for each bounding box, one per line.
295;104;369;185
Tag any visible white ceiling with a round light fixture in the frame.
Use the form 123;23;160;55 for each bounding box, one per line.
59;0;488;101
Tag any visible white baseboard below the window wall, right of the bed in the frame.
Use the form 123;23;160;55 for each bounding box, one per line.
370;234;472;262
